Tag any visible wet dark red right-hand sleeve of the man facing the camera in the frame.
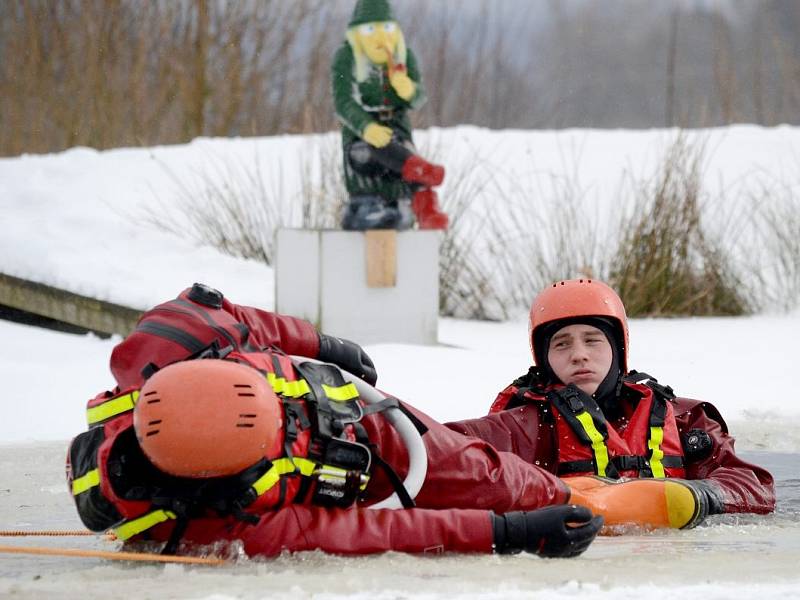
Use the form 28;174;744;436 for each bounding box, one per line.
675;398;775;514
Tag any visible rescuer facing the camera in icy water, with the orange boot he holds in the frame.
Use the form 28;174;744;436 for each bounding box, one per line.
447;279;775;528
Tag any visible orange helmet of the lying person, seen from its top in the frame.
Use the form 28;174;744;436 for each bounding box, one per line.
133;359;283;478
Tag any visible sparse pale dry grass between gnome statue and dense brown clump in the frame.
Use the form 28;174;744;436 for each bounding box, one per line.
439;139;602;320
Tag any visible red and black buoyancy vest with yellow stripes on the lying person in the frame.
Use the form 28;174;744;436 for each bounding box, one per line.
67;353;386;540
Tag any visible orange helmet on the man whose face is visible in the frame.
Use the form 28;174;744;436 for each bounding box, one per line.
528;279;628;373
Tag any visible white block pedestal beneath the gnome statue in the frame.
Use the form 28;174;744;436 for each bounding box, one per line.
275;229;441;344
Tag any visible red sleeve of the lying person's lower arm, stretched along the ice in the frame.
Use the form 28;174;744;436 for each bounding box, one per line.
177;505;493;556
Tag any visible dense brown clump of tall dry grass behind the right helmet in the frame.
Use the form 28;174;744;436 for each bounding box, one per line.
609;135;753;316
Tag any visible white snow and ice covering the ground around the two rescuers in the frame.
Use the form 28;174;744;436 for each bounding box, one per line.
0;127;800;599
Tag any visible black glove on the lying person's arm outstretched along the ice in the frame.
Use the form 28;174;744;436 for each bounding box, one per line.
492;504;603;558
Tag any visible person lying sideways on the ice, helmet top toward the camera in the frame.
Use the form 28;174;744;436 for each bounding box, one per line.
67;284;602;556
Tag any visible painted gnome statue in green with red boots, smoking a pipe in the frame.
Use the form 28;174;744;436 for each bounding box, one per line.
331;0;448;230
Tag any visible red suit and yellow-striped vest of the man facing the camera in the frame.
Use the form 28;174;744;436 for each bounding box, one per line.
446;367;775;514
